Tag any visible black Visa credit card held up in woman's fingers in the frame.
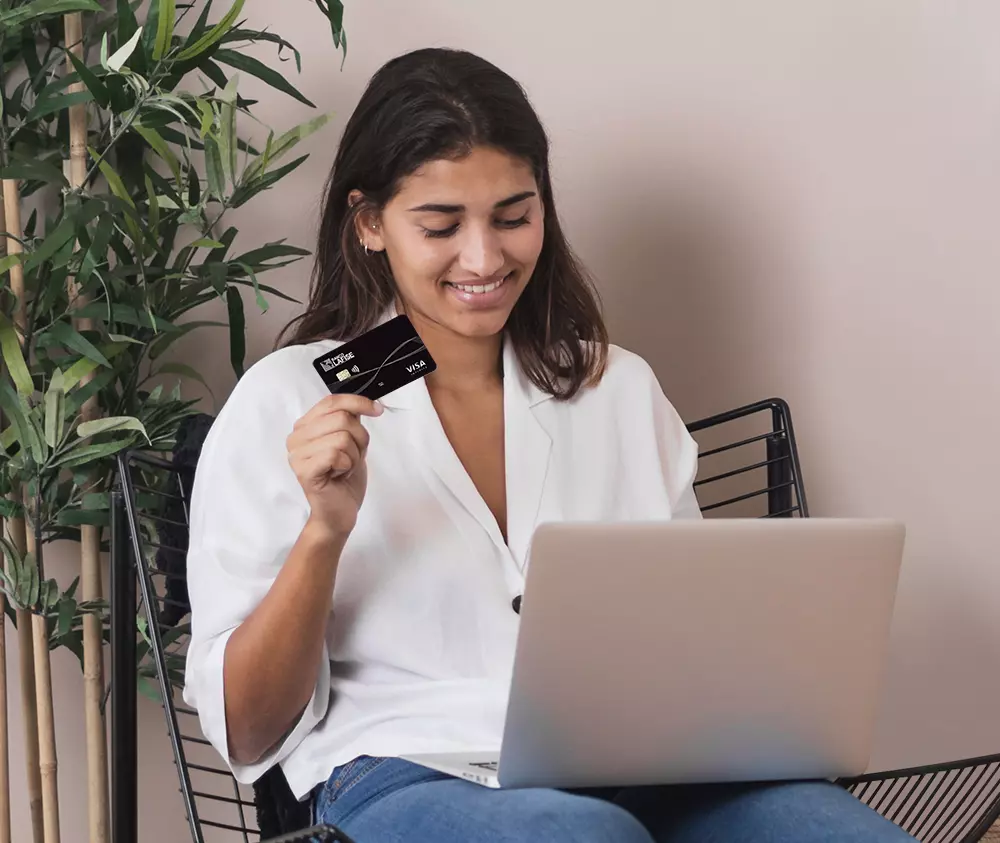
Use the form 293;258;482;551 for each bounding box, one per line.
313;315;437;401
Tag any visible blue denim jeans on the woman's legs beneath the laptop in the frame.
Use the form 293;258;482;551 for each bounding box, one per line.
313;756;913;843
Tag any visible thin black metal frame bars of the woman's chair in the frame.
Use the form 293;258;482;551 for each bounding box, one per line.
110;398;1000;843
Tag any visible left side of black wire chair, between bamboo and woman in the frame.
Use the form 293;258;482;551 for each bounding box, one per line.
111;452;352;843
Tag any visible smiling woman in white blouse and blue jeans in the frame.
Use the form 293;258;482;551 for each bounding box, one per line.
185;50;908;843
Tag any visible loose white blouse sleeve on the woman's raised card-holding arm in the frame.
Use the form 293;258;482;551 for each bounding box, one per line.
184;348;330;783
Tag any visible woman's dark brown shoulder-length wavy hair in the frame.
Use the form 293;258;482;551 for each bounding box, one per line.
275;49;608;399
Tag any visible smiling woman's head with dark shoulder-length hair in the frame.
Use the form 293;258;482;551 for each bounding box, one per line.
270;50;608;397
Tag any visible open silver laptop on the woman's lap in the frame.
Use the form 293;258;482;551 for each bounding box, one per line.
405;518;905;788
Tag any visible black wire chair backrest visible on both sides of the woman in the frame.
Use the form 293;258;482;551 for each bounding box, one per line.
113;400;807;843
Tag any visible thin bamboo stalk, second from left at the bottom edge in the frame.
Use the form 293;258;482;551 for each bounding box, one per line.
3;179;44;843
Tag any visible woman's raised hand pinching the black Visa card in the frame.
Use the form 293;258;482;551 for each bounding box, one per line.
285;394;383;538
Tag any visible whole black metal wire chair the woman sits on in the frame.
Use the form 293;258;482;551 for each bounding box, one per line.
112;399;1000;843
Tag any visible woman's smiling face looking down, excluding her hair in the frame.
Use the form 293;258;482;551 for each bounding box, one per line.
361;147;544;337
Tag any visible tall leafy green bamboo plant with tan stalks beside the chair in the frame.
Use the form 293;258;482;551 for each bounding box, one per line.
0;0;346;843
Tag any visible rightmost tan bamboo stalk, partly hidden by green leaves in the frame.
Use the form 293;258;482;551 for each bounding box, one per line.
63;12;109;843
